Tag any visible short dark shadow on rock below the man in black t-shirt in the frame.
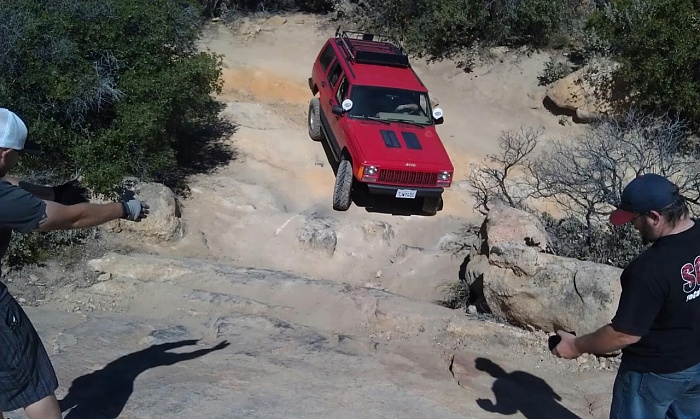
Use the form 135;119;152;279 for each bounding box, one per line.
474;358;579;419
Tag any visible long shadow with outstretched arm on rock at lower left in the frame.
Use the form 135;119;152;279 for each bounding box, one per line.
59;340;229;419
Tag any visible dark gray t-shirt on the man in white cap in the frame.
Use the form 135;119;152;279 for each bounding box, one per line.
0;179;46;303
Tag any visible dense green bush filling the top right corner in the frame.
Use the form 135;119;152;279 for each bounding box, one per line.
591;0;700;121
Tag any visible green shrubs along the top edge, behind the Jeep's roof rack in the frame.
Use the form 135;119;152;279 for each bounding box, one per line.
359;0;589;58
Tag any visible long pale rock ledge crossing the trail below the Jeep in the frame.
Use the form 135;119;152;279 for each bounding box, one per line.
53;253;542;347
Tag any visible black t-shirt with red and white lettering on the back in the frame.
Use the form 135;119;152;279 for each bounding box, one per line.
612;221;700;373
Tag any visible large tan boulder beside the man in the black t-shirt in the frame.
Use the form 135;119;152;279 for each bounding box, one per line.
466;206;621;333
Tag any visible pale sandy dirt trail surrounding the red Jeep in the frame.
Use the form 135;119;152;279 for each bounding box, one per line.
170;15;569;283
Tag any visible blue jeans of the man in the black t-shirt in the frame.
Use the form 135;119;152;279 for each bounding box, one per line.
610;362;700;419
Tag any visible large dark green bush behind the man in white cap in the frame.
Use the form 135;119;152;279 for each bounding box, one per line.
0;0;222;197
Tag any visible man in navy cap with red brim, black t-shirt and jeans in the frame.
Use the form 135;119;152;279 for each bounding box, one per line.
553;174;700;419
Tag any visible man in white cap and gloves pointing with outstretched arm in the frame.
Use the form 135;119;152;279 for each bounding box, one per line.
0;108;148;419
